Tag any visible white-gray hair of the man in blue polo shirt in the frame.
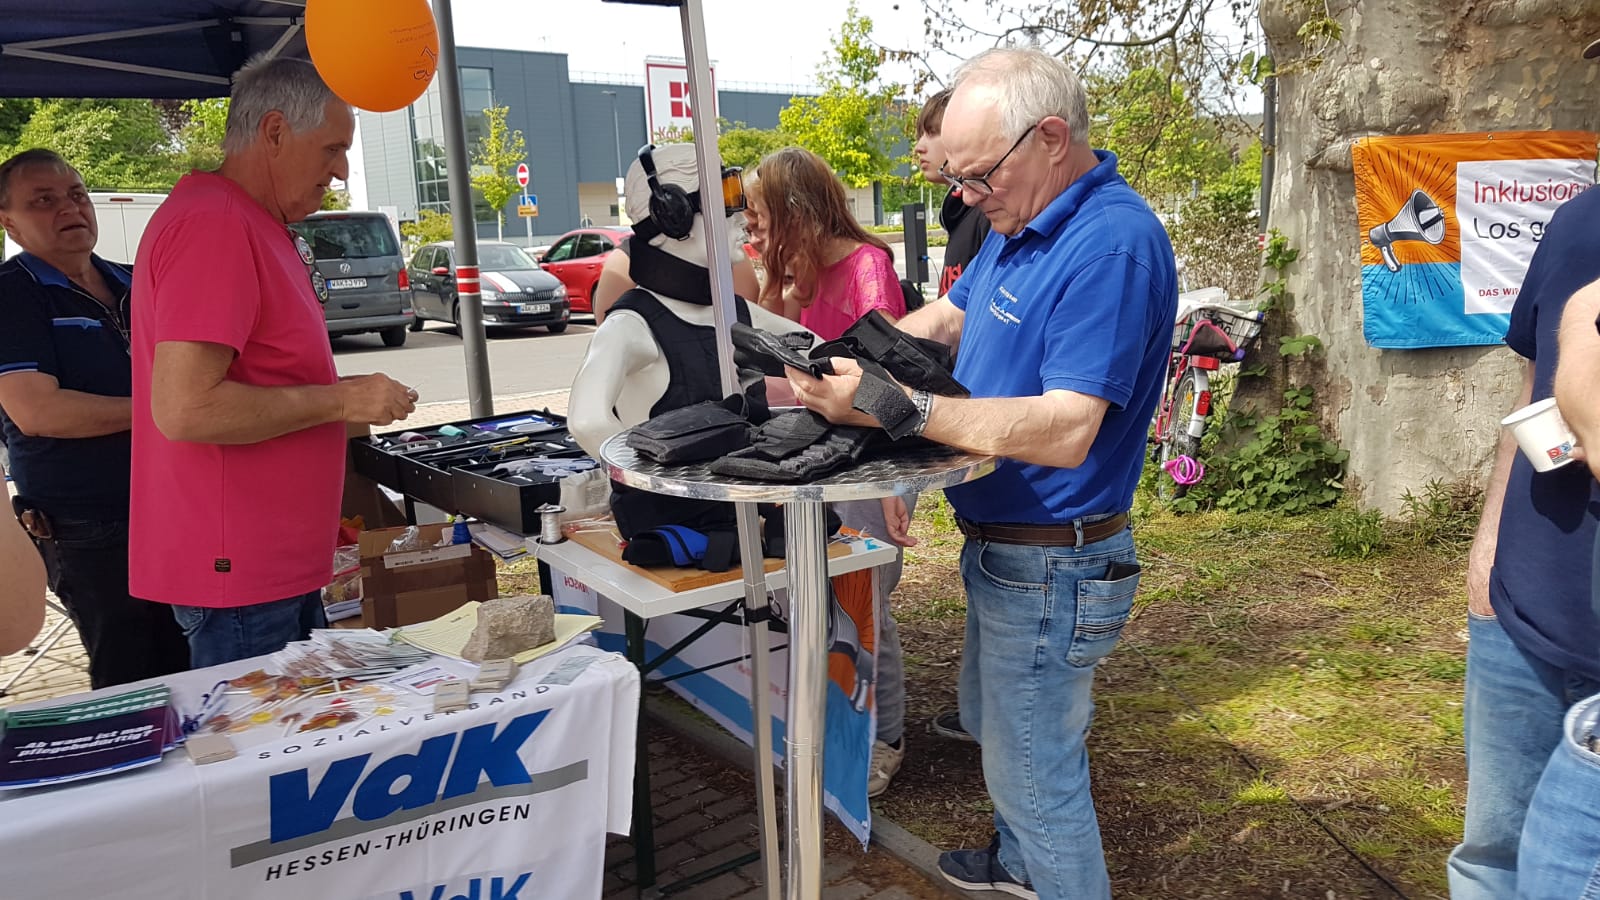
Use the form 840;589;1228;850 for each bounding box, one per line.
954;46;1090;146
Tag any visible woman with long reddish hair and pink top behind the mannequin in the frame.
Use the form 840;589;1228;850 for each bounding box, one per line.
744;147;906;341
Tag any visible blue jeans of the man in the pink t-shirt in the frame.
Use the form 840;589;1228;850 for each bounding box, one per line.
173;589;328;669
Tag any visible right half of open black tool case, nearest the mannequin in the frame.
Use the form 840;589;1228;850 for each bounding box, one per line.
450;434;592;535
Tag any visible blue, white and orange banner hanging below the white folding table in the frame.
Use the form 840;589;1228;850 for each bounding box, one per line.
550;528;885;846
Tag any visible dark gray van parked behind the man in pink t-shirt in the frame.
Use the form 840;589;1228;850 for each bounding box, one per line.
290;210;411;348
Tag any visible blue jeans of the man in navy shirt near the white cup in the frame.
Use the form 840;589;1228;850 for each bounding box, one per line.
1448;615;1600;900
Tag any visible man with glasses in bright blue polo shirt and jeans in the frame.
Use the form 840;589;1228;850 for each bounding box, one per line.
790;50;1178;900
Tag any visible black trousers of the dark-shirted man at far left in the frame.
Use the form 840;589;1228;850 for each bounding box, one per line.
34;519;189;689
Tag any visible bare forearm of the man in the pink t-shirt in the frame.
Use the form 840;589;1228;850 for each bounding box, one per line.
152;380;344;444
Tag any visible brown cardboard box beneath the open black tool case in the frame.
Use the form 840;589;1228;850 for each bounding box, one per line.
362;525;499;628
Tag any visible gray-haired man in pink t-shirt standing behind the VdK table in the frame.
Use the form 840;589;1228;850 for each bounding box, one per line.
128;59;416;668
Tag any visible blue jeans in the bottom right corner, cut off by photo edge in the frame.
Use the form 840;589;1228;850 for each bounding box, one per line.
1517;695;1600;900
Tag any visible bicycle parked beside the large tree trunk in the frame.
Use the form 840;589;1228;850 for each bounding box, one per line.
1150;288;1266;500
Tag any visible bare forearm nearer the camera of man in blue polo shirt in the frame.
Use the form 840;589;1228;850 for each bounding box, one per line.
923;391;1106;468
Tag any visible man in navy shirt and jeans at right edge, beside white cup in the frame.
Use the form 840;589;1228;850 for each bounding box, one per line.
1450;178;1600;900
